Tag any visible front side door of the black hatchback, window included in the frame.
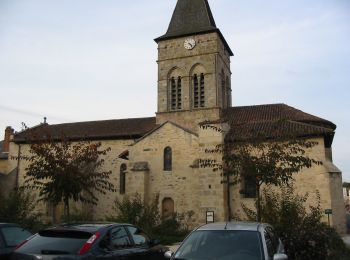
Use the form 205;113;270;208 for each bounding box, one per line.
126;225;165;260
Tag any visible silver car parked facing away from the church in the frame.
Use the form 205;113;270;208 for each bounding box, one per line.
165;222;288;260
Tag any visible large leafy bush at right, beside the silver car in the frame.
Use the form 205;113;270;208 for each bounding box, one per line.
242;185;350;260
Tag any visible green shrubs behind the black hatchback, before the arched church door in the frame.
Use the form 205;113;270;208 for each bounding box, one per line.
106;194;194;244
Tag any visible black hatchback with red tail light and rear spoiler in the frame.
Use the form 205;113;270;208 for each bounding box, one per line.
11;223;167;260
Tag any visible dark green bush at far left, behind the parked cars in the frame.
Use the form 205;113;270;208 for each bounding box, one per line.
0;190;42;231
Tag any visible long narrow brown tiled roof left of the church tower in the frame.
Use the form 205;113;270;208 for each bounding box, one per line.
14;117;156;142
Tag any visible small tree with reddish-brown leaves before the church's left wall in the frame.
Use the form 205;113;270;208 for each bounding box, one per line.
16;135;115;221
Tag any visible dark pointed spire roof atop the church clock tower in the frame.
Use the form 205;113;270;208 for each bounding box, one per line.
155;0;233;55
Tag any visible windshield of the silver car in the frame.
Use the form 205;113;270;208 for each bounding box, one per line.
175;230;264;260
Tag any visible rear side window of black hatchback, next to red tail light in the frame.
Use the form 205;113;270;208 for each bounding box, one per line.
100;227;131;250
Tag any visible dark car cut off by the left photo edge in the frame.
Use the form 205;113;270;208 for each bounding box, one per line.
0;223;33;260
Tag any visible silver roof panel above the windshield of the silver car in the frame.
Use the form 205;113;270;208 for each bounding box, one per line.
197;221;267;231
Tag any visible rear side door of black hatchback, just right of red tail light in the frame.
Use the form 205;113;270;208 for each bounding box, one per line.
94;226;135;260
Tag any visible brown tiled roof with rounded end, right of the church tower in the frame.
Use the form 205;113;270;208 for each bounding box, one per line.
223;104;336;141
